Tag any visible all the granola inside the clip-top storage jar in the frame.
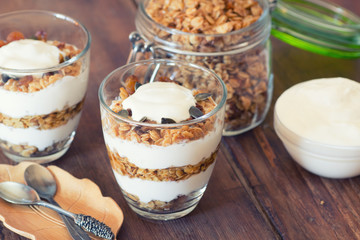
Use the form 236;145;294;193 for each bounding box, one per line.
146;0;270;131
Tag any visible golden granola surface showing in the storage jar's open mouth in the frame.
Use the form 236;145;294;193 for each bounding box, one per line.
146;0;262;34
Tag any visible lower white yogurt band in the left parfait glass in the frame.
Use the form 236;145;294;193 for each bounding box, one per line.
0;112;81;151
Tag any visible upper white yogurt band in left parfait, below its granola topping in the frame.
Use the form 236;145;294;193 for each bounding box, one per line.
0;68;89;118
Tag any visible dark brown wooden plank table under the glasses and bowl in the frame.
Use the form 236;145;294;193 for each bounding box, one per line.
0;0;360;240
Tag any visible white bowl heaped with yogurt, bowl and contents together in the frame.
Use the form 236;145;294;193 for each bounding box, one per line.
274;77;360;178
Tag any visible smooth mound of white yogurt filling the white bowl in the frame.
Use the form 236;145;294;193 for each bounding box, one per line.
275;78;360;146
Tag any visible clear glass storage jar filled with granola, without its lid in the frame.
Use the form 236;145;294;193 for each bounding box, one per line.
135;0;273;136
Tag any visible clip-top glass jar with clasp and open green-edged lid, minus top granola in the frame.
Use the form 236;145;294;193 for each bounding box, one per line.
129;0;360;136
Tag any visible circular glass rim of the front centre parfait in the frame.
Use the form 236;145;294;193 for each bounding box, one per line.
98;59;227;128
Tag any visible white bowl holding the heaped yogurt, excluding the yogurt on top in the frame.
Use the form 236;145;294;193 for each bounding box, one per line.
274;78;360;178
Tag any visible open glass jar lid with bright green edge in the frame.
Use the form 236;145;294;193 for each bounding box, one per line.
271;0;360;58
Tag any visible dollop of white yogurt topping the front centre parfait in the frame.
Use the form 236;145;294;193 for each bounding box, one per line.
122;82;196;123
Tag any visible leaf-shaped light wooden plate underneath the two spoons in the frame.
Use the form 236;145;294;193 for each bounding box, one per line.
0;162;124;240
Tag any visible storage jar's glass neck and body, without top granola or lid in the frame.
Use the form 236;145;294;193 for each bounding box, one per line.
135;0;273;136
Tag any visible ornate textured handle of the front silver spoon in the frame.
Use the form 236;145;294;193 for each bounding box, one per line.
36;200;115;239
